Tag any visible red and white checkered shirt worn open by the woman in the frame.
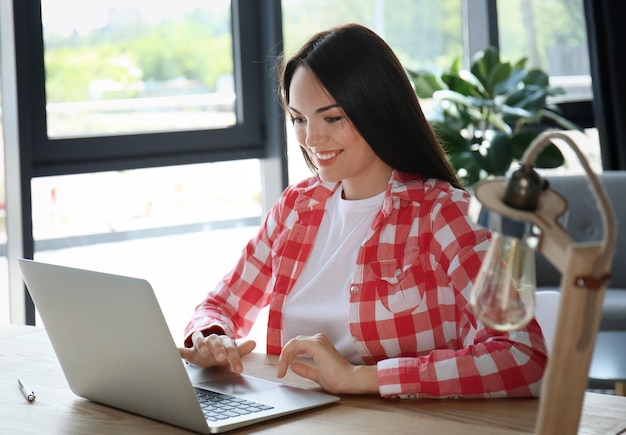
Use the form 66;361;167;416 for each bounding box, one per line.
186;171;547;398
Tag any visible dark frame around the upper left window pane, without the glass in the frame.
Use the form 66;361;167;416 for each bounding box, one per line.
14;0;267;176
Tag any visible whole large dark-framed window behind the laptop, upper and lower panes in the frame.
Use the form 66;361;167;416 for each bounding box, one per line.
7;0;284;328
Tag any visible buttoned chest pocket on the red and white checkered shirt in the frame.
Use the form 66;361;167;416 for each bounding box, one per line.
370;253;423;314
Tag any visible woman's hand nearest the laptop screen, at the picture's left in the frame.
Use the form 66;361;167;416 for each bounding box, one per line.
178;331;256;373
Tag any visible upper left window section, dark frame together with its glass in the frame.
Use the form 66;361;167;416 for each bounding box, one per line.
15;0;267;176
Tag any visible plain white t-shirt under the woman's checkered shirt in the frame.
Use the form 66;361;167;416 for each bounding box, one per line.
283;189;385;364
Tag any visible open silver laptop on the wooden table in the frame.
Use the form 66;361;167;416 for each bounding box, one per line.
19;259;339;433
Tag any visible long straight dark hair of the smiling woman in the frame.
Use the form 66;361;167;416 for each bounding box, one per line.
278;24;462;188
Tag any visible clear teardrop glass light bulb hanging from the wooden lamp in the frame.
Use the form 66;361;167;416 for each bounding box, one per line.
470;228;537;331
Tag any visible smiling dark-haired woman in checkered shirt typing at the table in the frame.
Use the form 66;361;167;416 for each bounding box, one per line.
180;24;547;397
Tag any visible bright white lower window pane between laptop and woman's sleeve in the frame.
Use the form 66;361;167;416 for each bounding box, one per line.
32;159;262;342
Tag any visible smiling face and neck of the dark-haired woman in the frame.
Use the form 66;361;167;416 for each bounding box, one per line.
288;66;392;199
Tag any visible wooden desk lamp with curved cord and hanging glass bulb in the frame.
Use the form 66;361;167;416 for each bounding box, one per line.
471;131;616;435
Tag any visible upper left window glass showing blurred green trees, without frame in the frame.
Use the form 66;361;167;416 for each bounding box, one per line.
41;0;236;138
